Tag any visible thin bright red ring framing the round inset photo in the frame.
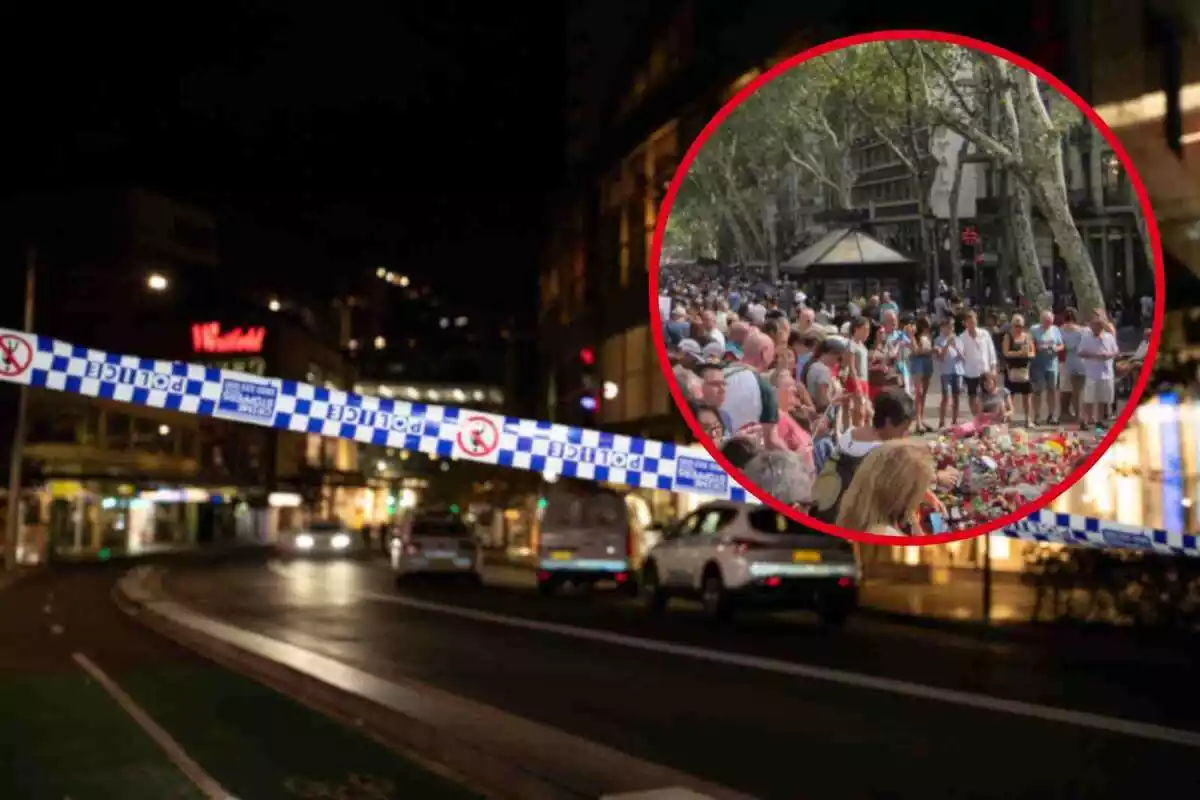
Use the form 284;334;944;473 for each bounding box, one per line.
649;30;1166;546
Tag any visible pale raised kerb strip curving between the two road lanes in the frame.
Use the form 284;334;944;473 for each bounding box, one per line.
114;566;751;800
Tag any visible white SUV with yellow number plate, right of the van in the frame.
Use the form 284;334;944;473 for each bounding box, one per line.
640;501;862;625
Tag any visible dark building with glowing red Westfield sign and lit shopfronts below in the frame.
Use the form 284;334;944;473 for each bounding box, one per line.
5;190;371;561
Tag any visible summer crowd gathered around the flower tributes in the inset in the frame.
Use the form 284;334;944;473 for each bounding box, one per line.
660;266;1150;534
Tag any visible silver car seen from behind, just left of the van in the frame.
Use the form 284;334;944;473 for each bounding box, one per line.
391;513;484;584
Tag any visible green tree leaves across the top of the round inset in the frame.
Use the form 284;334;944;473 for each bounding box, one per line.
666;40;1086;268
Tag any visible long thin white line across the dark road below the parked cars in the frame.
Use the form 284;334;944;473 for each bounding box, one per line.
361;593;1200;748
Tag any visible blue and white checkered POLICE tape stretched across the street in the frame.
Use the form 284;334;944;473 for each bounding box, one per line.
0;329;1200;557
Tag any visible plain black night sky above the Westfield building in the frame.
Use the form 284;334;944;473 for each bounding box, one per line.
0;0;563;326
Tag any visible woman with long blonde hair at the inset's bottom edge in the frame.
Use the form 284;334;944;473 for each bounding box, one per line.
836;439;942;536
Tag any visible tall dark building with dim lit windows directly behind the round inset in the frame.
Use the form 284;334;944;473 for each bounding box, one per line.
539;0;1089;439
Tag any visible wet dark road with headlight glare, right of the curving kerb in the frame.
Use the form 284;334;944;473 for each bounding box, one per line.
167;561;1200;798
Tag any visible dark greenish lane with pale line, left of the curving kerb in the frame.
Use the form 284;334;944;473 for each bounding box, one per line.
0;567;478;800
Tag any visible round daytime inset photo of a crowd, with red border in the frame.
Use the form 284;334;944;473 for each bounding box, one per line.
650;31;1163;545
